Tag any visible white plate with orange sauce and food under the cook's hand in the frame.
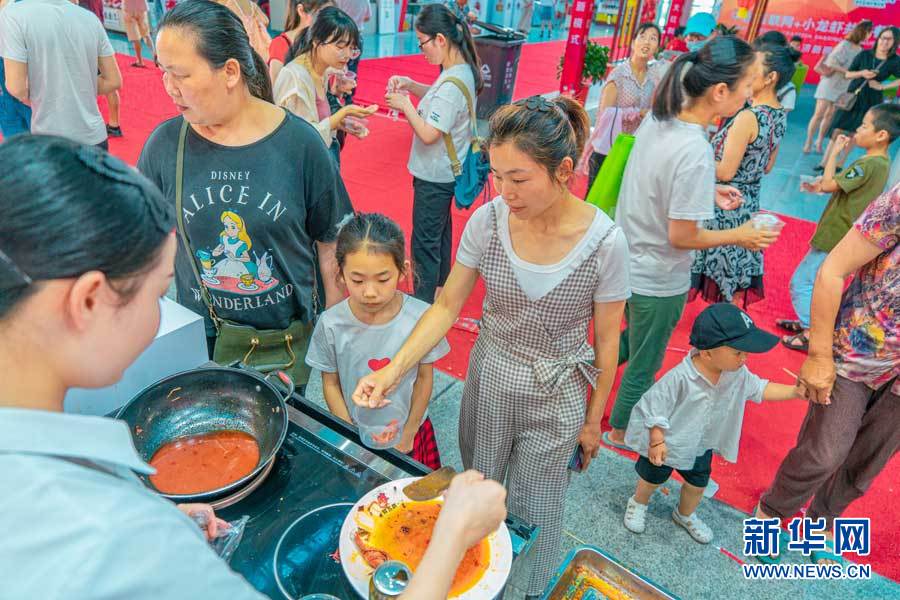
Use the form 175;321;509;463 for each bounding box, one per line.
339;477;513;600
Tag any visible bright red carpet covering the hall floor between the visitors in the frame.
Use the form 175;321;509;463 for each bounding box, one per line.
52;52;900;580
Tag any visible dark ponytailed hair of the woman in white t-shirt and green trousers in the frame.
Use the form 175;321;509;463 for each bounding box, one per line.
653;36;755;121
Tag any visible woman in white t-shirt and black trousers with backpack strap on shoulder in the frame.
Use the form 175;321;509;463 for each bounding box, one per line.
385;4;483;302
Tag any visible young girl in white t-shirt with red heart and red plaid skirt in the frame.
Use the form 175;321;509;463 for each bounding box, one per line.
306;214;450;469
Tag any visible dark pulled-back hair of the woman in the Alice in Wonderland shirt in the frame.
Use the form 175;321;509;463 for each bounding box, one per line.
159;0;272;102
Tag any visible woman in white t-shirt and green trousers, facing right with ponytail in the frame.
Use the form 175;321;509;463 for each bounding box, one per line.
603;37;778;446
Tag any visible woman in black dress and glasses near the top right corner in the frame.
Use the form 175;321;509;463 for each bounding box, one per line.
816;27;900;171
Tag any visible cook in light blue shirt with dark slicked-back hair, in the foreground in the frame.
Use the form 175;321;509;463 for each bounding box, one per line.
0;136;506;600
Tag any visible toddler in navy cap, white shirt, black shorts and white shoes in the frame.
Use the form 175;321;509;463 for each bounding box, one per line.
625;303;805;544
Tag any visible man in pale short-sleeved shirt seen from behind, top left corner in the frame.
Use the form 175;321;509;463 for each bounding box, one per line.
0;0;122;148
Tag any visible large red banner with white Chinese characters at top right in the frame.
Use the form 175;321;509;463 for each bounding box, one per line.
719;0;900;83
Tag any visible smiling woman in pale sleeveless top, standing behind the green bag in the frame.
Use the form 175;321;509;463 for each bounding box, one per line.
582;23;669;189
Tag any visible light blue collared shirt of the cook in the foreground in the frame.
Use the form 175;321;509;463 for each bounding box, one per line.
0;408;265;600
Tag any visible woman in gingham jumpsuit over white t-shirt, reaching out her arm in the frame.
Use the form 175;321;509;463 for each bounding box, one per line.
353;96;630;595
